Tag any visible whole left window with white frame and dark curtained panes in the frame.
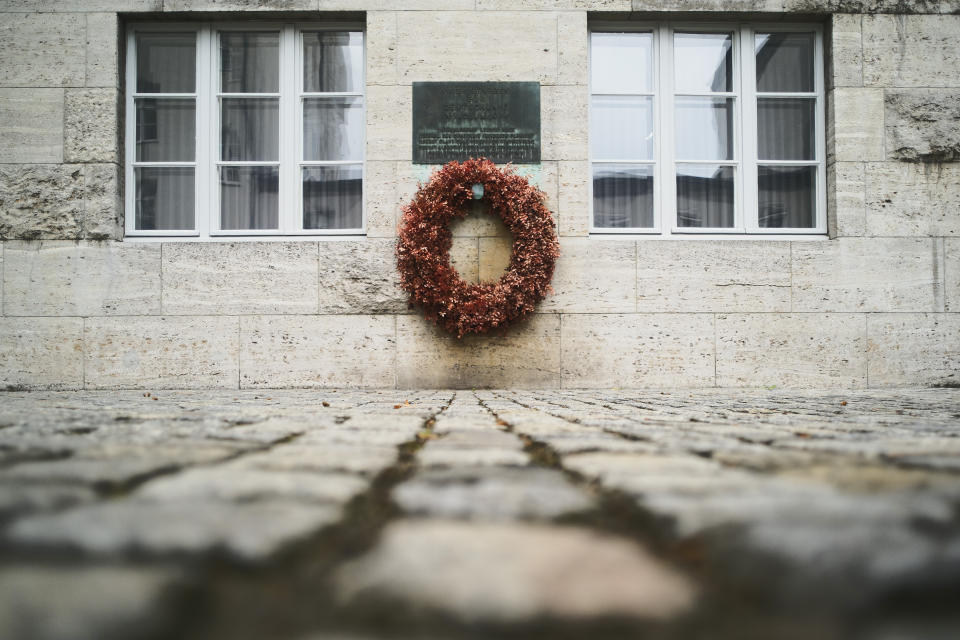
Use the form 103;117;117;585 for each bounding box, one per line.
126;23;364;238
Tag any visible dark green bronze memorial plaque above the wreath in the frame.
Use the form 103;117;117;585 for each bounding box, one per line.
413;82;540;164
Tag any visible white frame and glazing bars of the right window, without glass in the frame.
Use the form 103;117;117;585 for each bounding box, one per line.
587;20;827;240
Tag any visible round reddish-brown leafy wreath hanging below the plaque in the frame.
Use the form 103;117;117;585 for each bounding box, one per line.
397;158;560;338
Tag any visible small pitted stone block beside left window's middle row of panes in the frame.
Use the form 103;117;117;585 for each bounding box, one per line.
63;89;120;162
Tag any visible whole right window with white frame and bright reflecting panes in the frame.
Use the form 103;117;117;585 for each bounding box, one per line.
590;23;826;236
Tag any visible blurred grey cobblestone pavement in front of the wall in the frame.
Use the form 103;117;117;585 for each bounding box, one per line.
0;389;960;640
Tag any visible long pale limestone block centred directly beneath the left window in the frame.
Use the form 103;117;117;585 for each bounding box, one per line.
163;242;317;315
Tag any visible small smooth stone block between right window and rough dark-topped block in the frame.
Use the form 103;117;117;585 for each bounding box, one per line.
827;87;886;162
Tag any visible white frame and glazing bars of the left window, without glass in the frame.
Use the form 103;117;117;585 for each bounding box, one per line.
124;22;367;241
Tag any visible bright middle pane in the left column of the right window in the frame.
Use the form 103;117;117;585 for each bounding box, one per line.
590;96;653;160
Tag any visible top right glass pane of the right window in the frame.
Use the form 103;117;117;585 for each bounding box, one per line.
755;33;814;91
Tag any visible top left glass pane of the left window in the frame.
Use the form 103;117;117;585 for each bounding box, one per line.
137;32;197;93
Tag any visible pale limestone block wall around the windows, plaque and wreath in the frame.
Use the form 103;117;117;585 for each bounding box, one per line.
0;0;960;389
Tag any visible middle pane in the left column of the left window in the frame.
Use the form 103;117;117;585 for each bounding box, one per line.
136;98;197;162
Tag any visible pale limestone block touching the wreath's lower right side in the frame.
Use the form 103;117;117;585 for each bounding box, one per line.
540;237;637;313
